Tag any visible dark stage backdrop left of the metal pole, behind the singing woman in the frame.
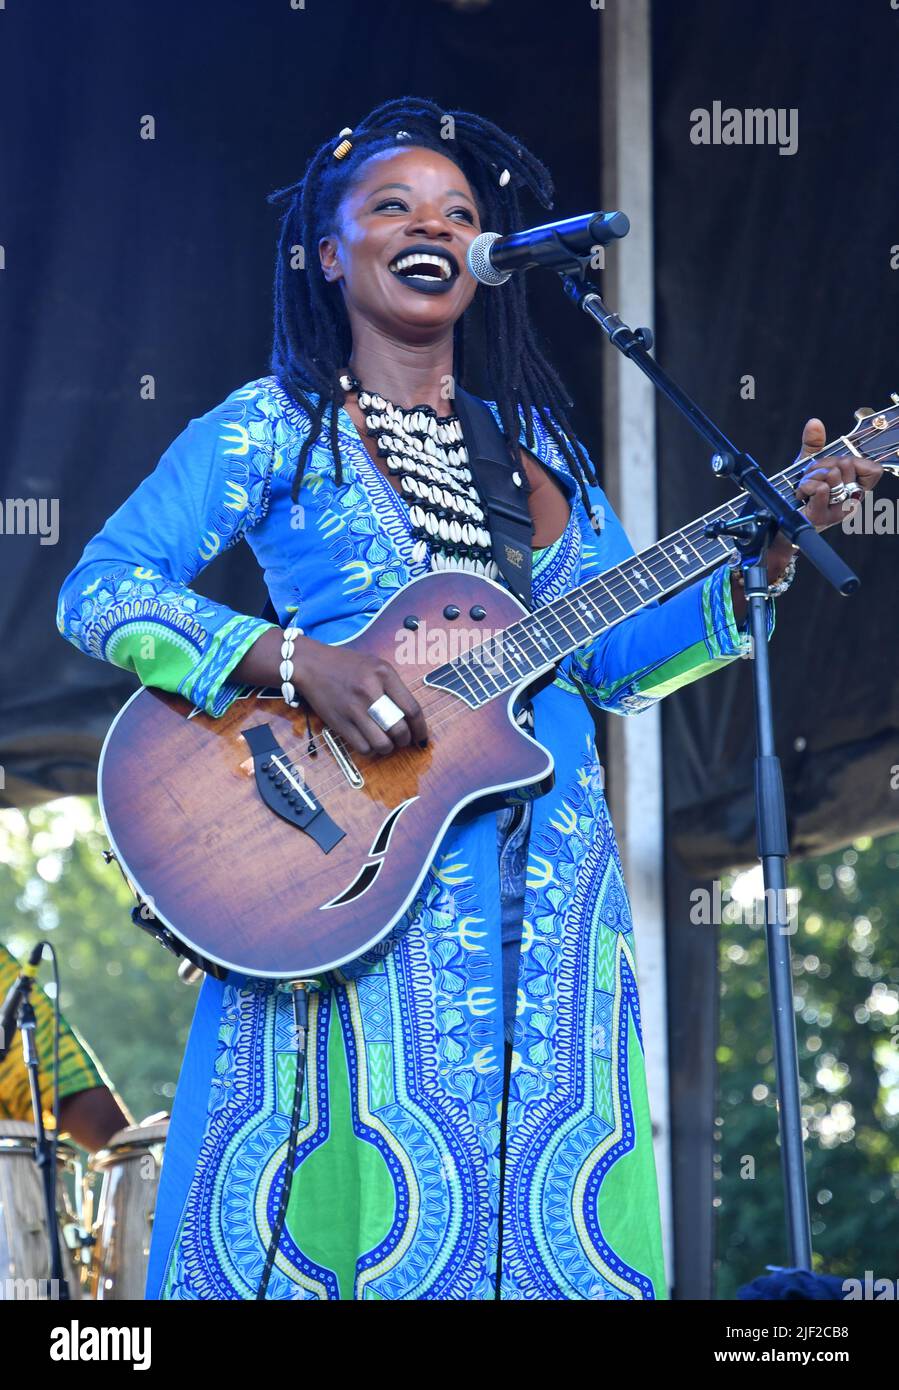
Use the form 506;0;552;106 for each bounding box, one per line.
0;0;602;805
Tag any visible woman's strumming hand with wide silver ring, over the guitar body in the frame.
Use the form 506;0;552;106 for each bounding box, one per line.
293;637;428;755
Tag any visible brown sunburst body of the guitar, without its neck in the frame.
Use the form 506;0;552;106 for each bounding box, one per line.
97;571;553;979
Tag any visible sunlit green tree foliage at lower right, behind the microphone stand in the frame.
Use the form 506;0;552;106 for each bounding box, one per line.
716;834;899;1298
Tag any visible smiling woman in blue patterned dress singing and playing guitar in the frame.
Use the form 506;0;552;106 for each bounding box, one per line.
58;99;875;1300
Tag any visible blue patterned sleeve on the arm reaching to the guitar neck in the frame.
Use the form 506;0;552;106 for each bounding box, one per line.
560;461;774;714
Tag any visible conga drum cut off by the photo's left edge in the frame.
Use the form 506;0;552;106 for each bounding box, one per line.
0;1120;81;1300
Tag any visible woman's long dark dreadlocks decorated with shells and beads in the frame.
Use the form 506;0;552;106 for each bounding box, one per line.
268;97;597;513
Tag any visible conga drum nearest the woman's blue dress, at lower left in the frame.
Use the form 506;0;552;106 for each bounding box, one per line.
90;1118;168;1301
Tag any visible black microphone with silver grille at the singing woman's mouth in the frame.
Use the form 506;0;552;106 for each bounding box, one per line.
467;213;631;285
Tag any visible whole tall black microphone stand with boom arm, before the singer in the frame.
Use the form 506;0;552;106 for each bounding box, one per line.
559;261;859;1270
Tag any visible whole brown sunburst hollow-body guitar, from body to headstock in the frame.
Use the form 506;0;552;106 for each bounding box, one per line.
97;398;899;980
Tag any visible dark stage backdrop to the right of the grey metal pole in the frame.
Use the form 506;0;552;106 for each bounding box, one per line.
653;0;899;1298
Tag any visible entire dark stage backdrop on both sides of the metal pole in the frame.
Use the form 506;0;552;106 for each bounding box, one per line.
0;0;899;1297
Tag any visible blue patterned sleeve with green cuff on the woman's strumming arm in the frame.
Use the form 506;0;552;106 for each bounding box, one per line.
57;385;275;717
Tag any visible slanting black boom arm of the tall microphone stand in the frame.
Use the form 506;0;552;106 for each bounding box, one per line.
560;272;860;594
